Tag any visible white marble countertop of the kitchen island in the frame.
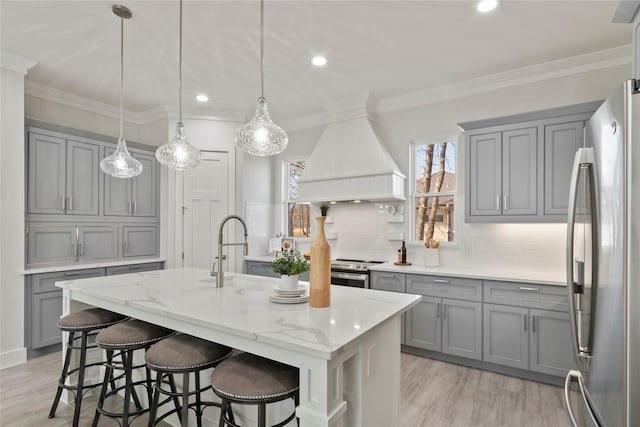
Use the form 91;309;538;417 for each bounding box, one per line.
56;268;421;359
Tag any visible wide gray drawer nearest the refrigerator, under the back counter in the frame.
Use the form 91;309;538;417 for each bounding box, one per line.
484;280;568;311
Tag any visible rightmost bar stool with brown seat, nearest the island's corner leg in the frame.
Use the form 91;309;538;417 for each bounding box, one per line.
211;353;299;427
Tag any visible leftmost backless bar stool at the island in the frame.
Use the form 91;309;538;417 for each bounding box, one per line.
49;308;127;427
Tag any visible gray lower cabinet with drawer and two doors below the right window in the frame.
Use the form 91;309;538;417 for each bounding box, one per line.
404;274;482;360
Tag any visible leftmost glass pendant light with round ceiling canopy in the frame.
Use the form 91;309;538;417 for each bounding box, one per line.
100;5;142;178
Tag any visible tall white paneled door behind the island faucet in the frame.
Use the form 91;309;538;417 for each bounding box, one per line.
182;151;229;269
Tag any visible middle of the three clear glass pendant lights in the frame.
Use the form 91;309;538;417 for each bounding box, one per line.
156;0;202;170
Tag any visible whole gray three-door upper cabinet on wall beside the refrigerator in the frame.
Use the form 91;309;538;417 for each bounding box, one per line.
460;102;600;223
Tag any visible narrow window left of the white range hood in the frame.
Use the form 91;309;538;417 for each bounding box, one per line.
285;160;311;237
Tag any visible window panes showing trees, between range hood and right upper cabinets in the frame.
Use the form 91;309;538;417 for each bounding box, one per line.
412;138;456;242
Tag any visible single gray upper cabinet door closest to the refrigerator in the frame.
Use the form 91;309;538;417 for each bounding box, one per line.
544;120;584;216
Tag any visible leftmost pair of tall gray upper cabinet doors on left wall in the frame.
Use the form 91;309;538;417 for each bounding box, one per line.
27;132;100;215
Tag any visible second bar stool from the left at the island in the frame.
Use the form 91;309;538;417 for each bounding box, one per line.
92;319;174;427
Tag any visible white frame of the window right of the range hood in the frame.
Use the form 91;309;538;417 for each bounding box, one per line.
407;135;461;248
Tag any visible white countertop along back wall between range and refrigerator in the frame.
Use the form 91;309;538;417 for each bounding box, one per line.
369;262;566;286
